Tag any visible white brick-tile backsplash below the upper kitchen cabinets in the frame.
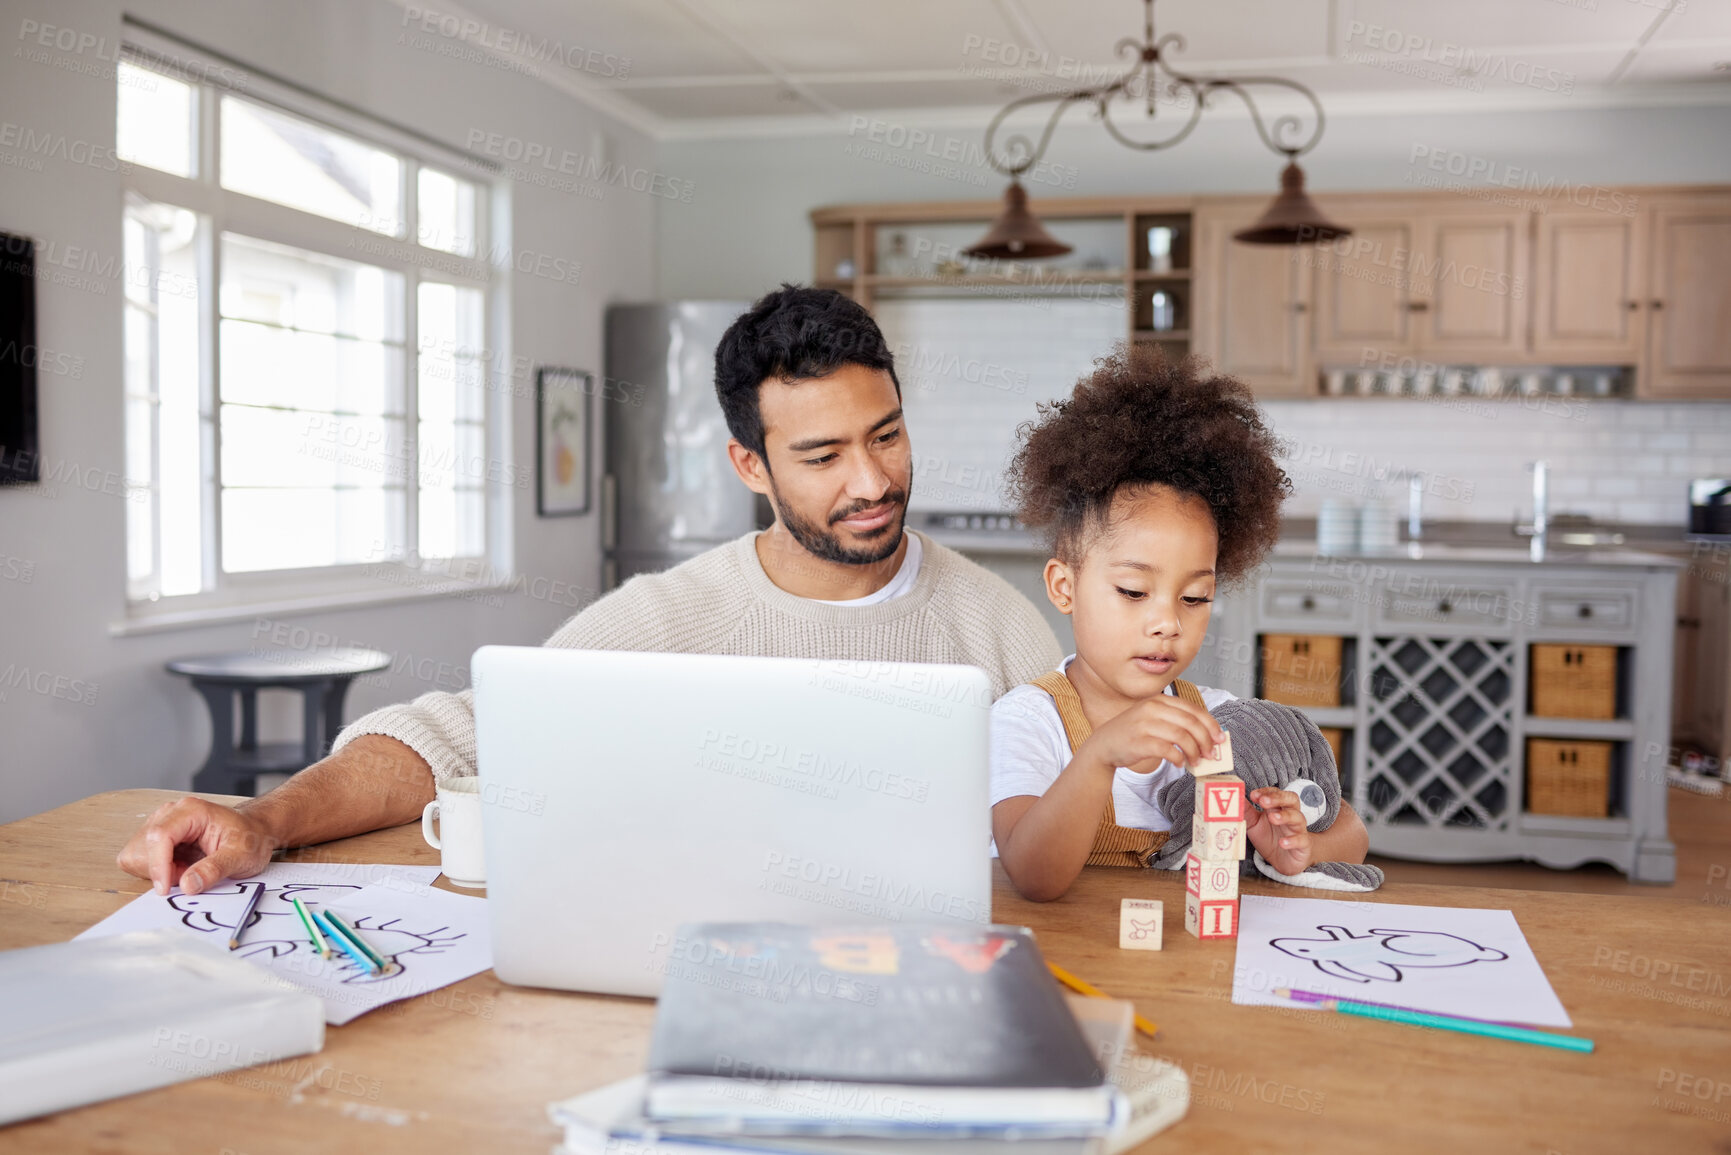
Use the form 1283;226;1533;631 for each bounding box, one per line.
874;298;1731;525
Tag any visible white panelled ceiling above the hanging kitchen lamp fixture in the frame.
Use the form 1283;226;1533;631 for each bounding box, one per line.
411;0;1731;137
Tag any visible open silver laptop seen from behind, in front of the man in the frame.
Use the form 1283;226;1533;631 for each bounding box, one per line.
471;646;992;996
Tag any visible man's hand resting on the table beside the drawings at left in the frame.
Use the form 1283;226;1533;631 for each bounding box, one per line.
116;795;277;894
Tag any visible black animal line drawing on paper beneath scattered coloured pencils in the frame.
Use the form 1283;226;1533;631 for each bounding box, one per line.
168;883;466;984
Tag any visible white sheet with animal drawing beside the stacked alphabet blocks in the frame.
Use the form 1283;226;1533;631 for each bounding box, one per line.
1232;895;1573;1027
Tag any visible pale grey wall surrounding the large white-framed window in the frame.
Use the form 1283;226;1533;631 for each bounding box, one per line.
0;0;656;823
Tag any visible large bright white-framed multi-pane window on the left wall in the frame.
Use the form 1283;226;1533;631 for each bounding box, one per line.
118;38;511;606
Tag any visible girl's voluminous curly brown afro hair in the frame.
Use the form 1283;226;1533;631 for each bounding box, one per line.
1009;343;1291;582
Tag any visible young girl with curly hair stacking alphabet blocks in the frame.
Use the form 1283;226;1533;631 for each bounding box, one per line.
992;345;1369;902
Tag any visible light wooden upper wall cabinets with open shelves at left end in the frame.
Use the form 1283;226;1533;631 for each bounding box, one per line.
812;185;1731;400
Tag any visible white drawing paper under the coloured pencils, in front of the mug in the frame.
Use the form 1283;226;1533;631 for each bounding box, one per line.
78;862;493;1025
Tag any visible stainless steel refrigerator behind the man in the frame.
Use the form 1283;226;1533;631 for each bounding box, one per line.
601;301;770;589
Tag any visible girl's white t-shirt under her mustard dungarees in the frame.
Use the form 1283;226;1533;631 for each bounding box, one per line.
992;655;1238;834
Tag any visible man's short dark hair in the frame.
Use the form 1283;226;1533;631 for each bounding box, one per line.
715;284;902;464
